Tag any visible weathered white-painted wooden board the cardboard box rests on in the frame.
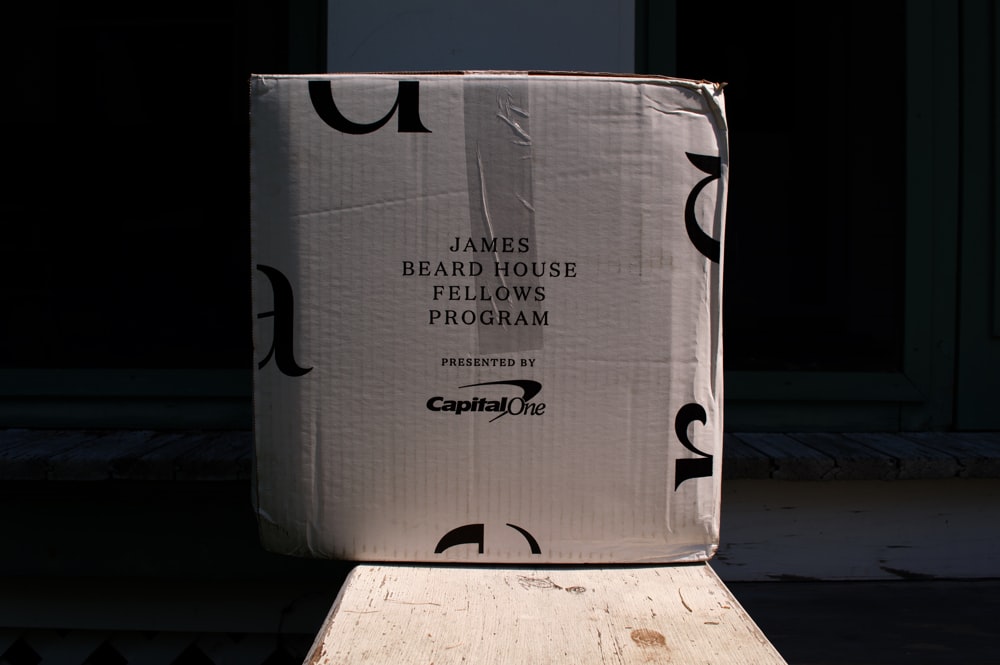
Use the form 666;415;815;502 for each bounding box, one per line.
305;564;785;665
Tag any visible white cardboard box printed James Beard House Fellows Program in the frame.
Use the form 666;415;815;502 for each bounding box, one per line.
251;72;729;563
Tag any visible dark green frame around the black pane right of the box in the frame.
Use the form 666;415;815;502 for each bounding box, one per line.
636;0;964;431
